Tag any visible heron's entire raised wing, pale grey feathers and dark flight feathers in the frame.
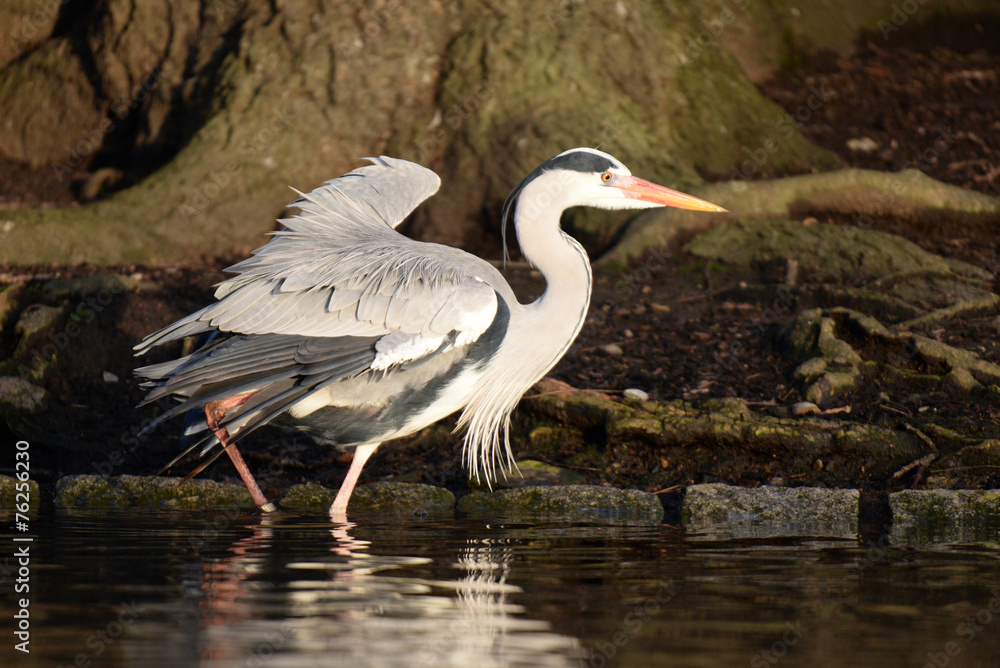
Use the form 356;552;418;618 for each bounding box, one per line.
136;158;500;456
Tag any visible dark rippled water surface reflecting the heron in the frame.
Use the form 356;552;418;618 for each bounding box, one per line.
0;510;1000;668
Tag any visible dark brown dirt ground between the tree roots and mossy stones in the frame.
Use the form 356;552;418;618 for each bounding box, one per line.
0;31;1000;500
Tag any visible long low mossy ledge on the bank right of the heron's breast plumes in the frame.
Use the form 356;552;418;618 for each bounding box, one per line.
522;383;926;486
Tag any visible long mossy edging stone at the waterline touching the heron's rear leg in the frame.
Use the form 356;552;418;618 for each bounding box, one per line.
56;475;254;508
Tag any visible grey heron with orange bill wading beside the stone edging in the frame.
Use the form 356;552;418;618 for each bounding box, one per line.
135;148;724;520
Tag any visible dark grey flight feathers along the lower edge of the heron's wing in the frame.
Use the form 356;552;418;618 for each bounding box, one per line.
136;334;377;438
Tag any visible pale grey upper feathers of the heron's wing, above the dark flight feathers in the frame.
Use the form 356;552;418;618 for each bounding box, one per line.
135;157;502;363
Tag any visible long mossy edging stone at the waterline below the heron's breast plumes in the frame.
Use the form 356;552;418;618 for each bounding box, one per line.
458;485;663;524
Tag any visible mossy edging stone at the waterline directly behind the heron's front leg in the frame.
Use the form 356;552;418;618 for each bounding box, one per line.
280;482;455;517
